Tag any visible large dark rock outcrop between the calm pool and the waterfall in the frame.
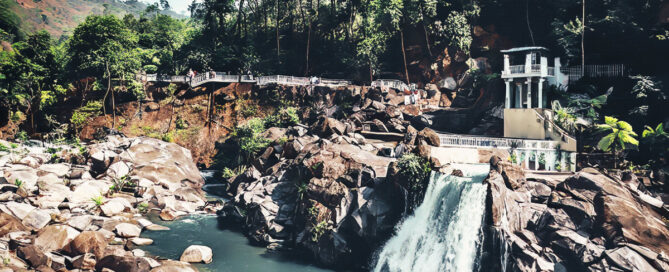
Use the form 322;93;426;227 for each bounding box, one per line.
221;123;405;266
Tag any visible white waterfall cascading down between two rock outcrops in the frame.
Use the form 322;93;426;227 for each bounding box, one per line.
373;164;489;272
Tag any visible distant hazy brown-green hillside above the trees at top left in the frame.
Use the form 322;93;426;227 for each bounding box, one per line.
2;0;183;37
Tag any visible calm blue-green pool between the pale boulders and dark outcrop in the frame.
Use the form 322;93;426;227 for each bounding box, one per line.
140;171;331;272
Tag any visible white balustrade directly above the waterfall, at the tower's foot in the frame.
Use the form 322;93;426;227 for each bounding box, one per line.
439;134;557;150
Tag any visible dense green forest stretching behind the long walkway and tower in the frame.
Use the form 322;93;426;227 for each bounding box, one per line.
0;0;669;169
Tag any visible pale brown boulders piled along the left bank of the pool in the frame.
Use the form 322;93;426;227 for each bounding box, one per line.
0;136;216;271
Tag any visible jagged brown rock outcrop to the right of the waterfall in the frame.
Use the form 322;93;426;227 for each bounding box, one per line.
484;157;669;271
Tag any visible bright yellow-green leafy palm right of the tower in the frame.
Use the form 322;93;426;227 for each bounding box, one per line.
597;116;639;168
